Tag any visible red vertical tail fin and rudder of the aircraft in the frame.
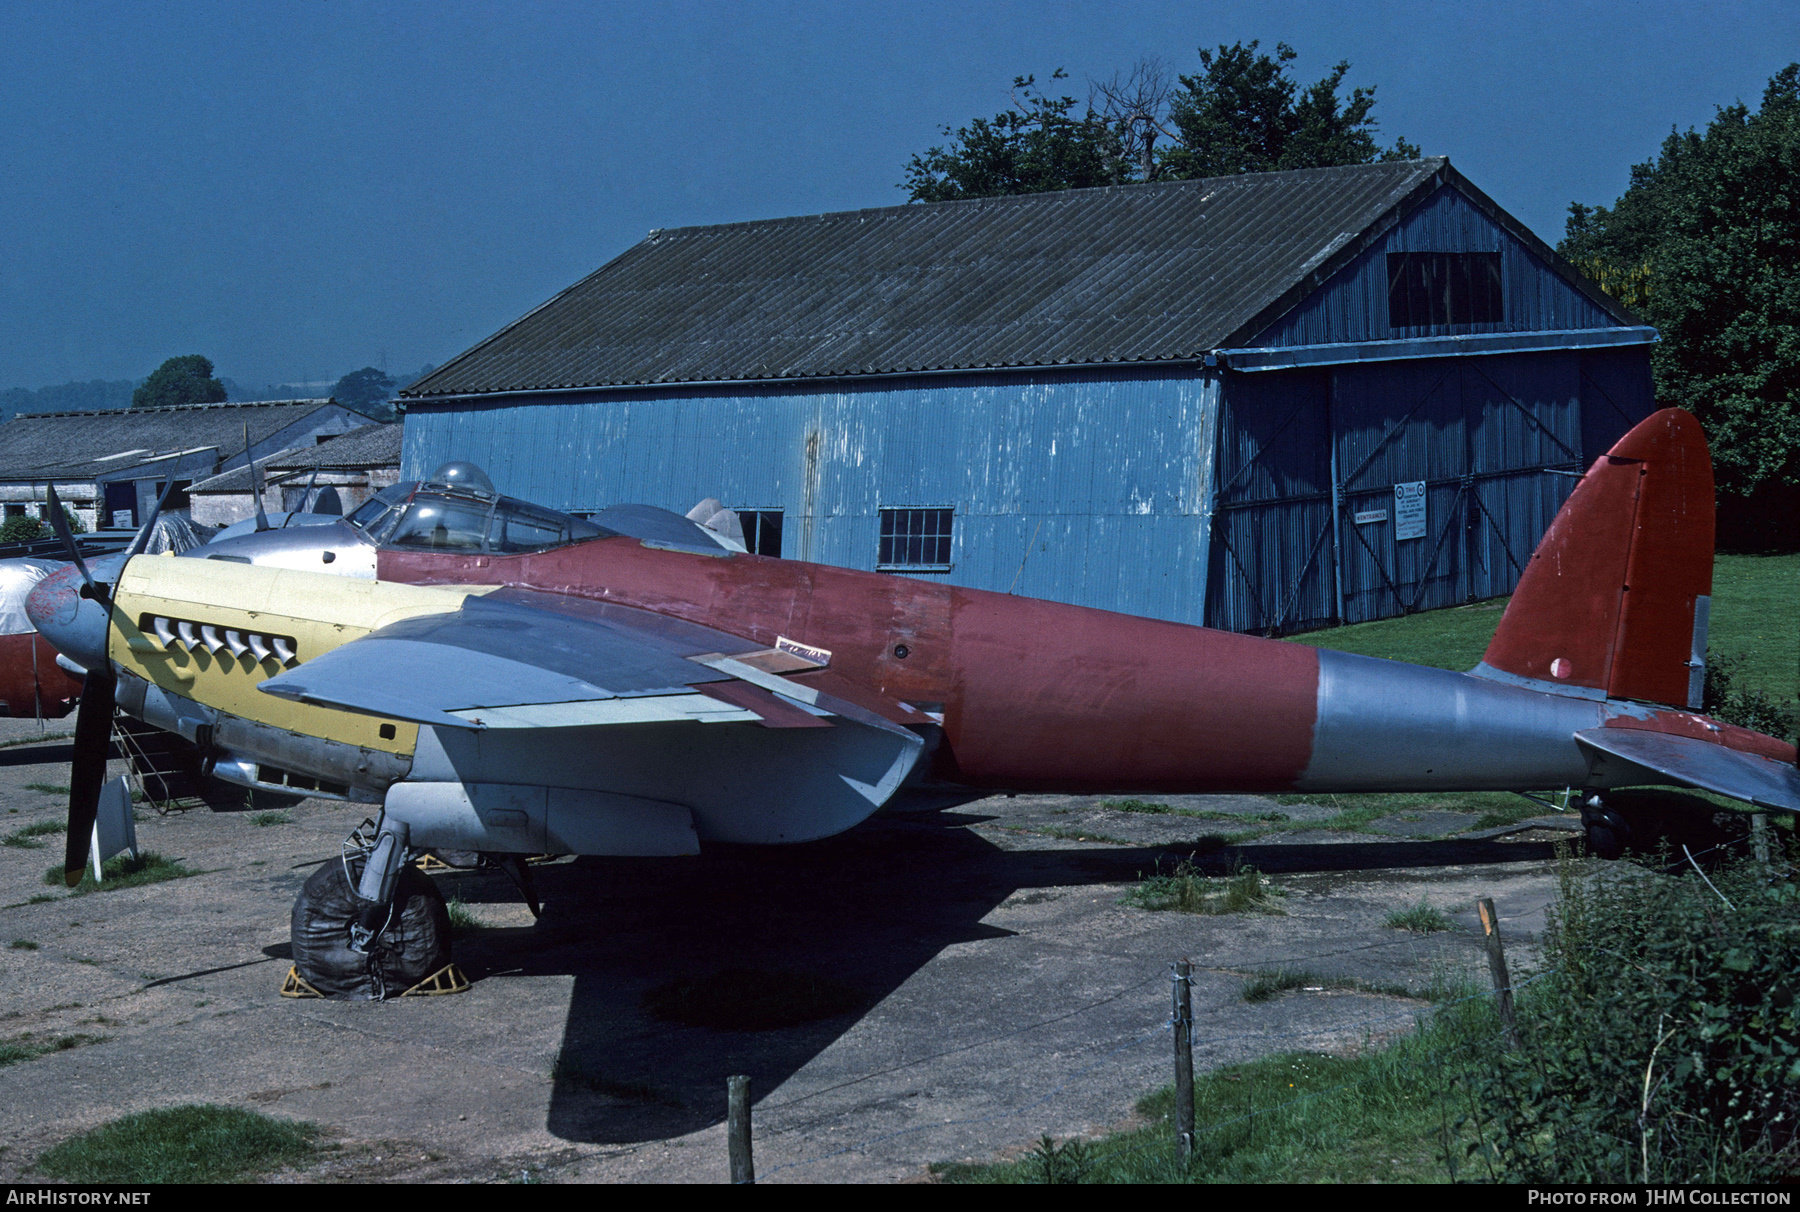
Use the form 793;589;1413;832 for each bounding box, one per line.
1474;409;1712;708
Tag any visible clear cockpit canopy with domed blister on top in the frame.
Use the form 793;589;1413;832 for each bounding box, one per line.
347;482;617;553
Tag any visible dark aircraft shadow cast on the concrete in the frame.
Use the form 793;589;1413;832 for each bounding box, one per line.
424;812;1550;1144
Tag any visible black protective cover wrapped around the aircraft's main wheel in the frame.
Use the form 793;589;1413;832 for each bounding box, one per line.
292;857;450;1001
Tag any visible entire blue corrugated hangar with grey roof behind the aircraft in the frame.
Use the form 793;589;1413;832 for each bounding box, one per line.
403;158;1656;634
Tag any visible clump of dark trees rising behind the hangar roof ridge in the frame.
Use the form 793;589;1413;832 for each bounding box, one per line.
902;41;1418;202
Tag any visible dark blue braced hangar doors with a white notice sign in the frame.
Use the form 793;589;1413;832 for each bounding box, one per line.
1208;353;1584;634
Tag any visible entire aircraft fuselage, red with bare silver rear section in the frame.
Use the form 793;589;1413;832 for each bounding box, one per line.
378;538;1795;792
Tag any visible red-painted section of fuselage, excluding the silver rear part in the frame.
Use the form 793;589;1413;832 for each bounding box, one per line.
378;538;1339;791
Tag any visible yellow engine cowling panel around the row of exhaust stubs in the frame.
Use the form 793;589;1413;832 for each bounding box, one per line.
110;556;491;755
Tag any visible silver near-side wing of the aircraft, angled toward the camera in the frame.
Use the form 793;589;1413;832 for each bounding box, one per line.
261;589;923;842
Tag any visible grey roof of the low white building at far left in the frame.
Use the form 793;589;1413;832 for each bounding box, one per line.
0;400;343;481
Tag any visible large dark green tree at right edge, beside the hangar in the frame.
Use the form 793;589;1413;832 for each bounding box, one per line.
1559;63;1800;547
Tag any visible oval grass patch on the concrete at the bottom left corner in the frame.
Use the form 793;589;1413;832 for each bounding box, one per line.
38;1106;319;1183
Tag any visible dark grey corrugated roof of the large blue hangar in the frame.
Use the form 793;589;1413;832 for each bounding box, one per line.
401;157;1460;398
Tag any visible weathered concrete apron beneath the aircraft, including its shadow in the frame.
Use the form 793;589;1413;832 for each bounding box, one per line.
0;720;1553;1181
